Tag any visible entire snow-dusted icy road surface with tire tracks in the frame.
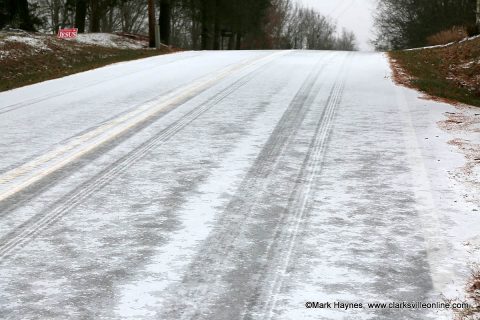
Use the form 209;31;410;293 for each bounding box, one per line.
0;51;480;320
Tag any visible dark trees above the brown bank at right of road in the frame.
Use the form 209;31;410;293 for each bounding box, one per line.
374;0;478;50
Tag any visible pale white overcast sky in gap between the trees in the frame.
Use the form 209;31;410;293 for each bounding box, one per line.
295;0;376;51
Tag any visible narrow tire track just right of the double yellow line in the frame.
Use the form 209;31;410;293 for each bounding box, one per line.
0;53;284;263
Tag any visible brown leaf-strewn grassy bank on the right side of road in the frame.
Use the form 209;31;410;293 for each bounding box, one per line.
390;37;480;106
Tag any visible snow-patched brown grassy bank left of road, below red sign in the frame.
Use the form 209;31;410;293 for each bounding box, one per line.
0;31;176;91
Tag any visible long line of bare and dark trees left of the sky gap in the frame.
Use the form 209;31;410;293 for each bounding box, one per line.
0;0;356;50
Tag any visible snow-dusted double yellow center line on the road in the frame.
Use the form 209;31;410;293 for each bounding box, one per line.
0;51;287;201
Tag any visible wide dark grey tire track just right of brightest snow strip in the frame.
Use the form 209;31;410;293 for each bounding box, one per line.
160;52;338;319
